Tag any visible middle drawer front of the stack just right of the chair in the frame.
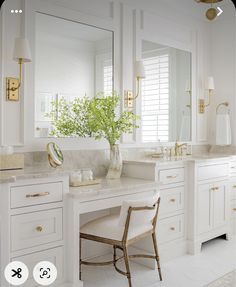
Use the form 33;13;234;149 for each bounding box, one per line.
160;186;184;216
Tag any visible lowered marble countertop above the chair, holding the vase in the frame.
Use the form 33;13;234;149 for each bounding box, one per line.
68;177;158;202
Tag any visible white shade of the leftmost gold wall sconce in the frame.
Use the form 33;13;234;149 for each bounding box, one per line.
13;38;31;62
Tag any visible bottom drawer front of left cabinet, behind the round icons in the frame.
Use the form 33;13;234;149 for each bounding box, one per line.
11;247;64;287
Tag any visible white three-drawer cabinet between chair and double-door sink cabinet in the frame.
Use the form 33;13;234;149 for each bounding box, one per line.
123;160;187;261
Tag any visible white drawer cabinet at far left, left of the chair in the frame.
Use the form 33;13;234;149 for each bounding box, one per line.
0;177;69;287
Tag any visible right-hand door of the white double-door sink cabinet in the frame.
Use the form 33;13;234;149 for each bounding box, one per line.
212;183;229;228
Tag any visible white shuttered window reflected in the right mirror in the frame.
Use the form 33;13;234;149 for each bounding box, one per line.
141;51;169;142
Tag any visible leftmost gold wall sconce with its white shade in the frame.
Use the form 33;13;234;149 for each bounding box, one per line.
6;38;31;101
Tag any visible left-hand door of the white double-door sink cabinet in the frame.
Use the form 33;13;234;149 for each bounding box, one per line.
197;184;213;234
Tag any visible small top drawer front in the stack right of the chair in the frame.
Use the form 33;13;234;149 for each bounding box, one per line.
159;168;184;184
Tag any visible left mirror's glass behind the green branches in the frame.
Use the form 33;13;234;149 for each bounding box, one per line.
35;13;113;137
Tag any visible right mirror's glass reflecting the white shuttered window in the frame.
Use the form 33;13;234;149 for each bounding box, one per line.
142;40;191;142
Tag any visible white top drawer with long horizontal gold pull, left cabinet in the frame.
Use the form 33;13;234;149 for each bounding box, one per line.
11;182;63;208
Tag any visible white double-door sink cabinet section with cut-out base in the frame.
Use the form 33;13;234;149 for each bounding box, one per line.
188;159;230;254
